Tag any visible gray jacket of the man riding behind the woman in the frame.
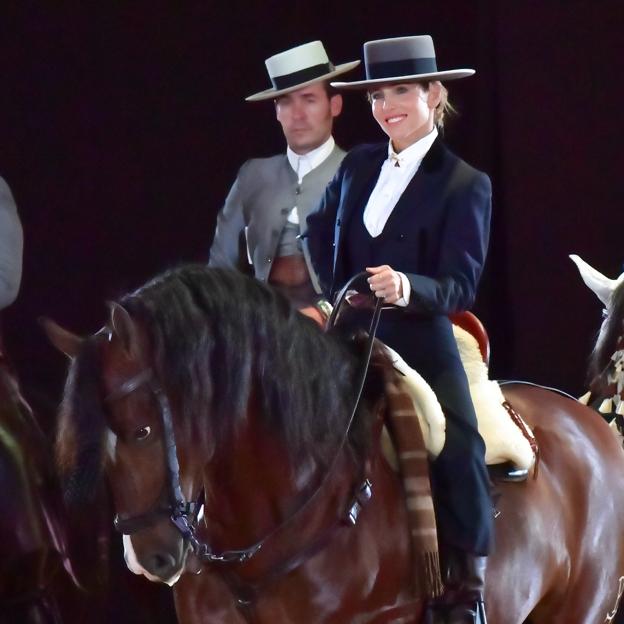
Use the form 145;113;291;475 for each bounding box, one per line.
208;146;345;293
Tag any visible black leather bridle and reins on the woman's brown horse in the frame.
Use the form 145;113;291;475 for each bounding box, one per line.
105;273;383;575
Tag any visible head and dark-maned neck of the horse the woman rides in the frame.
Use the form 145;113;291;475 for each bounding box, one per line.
48;267;381;596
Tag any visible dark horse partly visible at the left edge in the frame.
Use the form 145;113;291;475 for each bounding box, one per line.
0;352;84;624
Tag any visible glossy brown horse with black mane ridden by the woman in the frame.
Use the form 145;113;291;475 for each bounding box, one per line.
50;267;624;624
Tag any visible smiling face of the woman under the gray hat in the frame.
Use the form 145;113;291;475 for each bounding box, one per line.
368;82;441;152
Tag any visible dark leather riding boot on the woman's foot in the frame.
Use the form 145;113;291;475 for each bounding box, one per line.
433;549;487;624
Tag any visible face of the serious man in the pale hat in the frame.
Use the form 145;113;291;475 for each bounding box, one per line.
275;82;342;154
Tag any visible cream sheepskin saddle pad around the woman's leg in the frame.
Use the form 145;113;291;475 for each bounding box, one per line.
384;325;535;470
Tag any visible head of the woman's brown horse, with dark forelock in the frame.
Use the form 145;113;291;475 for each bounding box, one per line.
45;304;205;584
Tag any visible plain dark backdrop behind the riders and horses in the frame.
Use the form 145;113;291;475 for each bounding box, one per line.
0;0;624;620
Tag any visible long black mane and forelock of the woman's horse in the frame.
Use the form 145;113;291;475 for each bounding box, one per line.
58;265;383;491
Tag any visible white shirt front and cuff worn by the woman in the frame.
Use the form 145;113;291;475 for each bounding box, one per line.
364;126;438;307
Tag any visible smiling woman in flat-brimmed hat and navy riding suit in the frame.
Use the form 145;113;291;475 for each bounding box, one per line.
307;35;492;624
